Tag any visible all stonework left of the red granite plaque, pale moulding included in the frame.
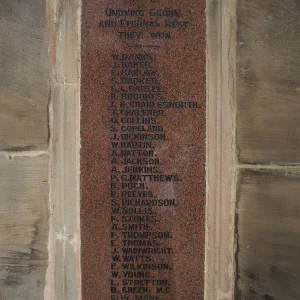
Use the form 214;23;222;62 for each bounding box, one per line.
0;0;80;300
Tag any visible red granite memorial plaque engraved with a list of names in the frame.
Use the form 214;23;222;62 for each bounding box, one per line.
81;0;206;300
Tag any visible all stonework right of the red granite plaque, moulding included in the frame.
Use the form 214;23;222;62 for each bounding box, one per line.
205;0;300;300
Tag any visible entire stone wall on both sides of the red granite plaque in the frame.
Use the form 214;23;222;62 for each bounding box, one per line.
0;0;300;300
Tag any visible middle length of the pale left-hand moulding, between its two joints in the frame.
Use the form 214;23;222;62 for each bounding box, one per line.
53;84;79;237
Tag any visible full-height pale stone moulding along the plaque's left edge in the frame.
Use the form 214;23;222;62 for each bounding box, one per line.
49;0;81;300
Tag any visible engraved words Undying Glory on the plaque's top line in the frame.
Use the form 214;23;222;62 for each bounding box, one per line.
105;8;181;18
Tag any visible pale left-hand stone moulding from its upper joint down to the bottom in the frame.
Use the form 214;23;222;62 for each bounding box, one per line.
52;84;80;300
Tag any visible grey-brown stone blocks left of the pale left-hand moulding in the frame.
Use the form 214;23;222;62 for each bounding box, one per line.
0;0;51;300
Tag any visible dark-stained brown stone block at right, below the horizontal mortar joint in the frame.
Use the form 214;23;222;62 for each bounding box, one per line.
235;170;300;300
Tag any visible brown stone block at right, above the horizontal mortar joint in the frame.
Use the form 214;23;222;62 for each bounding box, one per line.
237;0;300;164
